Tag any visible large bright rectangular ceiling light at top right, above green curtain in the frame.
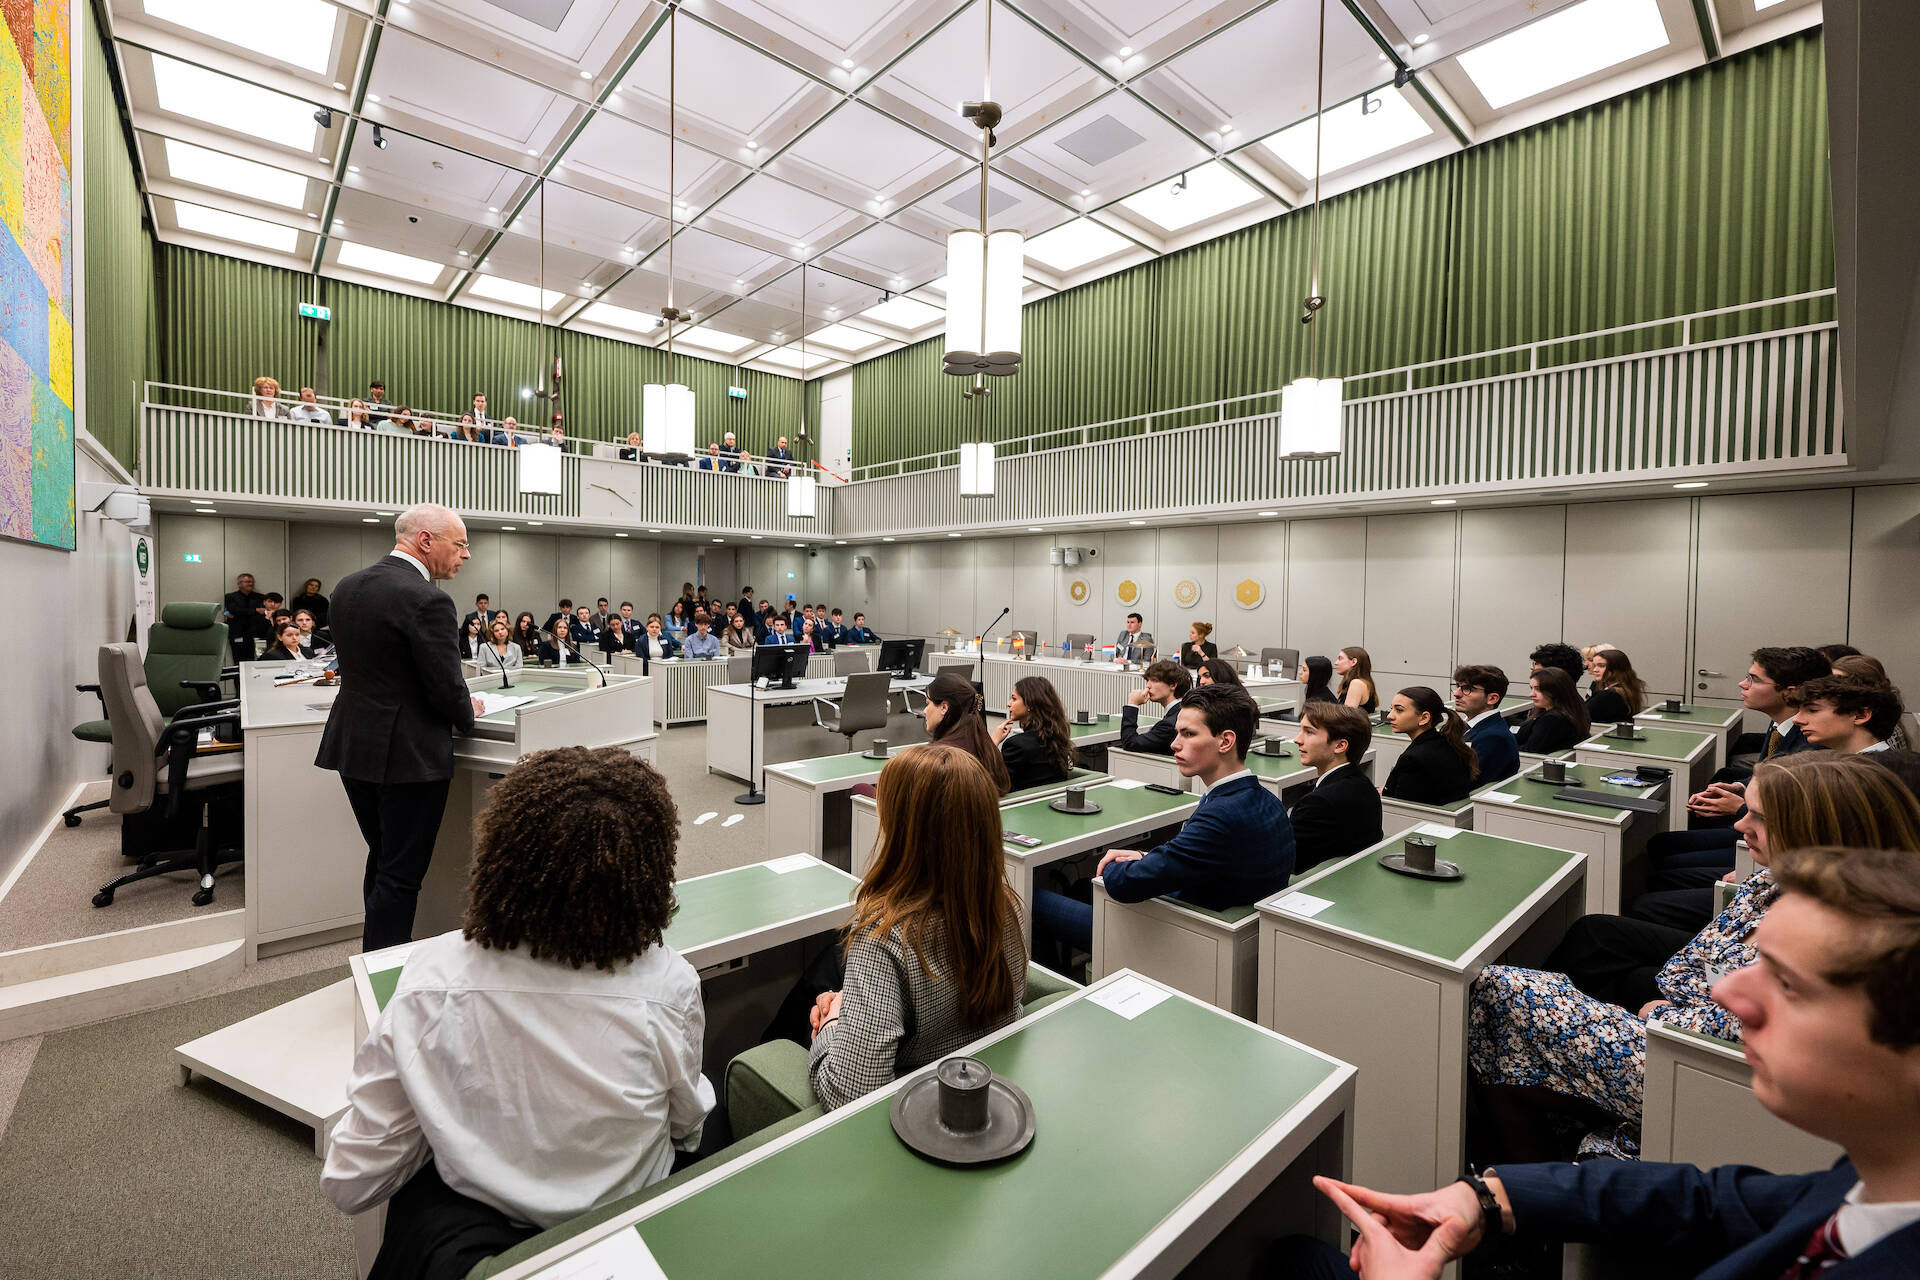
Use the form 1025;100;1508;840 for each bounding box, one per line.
1457;0;1667;111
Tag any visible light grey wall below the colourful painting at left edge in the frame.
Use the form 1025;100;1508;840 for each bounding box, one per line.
0;439;132;886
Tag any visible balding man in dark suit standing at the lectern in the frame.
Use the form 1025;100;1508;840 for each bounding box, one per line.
315;503;480;952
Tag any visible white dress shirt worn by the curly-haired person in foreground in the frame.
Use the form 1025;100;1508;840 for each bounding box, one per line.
321;933;714;1226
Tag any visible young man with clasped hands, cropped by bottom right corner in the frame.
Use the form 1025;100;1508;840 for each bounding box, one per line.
1271;848;1920;1280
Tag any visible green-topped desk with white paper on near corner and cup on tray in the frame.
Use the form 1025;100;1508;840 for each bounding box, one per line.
1258;827;1586;1192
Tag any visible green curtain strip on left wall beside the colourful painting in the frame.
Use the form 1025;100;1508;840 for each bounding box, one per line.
73;4;156;468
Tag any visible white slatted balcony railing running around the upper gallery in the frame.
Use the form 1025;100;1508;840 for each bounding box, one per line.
140;290;1847;541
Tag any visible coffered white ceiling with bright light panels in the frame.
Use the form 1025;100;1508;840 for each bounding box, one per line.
108;0;1820;376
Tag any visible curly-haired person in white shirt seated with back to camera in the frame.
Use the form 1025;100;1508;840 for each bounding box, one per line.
321;747;714;1278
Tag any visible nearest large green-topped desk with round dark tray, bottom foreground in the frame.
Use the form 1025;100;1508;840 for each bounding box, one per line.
480;973;1354;1280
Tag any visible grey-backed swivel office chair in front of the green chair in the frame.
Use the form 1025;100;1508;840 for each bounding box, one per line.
94;645;246;906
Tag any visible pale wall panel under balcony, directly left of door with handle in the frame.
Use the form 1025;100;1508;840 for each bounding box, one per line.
1566;497;1689;695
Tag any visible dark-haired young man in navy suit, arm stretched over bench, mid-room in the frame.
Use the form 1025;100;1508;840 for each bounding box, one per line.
1033;685;1294;963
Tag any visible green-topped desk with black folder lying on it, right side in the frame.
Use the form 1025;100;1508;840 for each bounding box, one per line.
1473;764;1667;915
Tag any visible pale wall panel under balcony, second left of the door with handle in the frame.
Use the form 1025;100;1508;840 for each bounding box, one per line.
1450;507;1567;699
